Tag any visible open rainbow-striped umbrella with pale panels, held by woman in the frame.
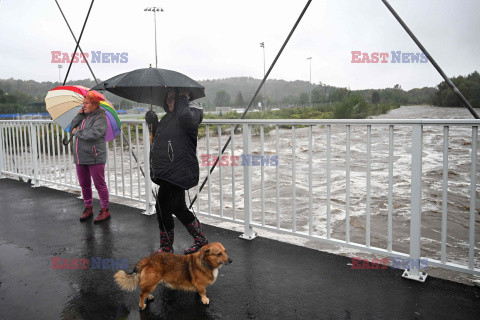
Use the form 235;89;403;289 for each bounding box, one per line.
45;86;122;141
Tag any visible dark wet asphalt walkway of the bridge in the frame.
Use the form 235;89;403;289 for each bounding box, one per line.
0;179;480;319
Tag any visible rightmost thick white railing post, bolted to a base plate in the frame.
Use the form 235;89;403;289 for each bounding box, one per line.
402;124;427;282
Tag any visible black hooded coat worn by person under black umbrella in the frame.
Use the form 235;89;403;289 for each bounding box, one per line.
145;96;203;190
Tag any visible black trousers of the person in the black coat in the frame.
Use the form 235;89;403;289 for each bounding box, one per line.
155;181;195;231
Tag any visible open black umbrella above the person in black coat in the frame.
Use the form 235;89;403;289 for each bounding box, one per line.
92;67;205;106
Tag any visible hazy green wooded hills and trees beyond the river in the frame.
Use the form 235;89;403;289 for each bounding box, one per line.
0;71;480;114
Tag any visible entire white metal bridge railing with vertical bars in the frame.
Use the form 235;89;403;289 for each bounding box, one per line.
0;119;480;278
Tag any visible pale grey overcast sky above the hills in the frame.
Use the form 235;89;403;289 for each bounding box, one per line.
0;0;480;89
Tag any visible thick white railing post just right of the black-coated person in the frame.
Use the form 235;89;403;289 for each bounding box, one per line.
240;124;257;240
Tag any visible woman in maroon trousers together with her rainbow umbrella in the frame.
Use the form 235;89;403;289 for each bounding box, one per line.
45;86;121;223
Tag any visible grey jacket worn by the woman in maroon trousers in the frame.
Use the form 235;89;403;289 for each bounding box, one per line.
70;107;107;165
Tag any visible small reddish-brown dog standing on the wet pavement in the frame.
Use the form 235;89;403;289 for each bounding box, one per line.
114;242;232;310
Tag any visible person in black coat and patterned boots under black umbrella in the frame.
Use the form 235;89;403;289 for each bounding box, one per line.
145;88;208;254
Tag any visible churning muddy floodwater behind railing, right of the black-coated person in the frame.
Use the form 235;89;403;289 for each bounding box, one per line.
191;106;480;272
